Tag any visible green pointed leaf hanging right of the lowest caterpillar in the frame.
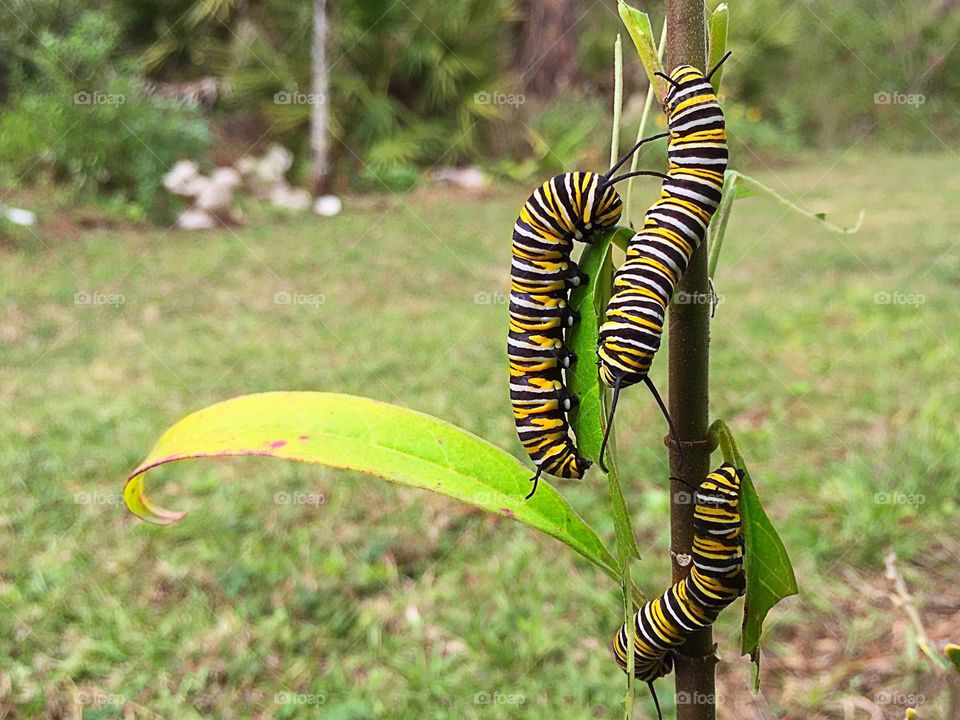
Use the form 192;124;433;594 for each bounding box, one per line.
709;420;799;690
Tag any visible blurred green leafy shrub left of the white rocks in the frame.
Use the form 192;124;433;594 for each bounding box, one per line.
0;3;210;220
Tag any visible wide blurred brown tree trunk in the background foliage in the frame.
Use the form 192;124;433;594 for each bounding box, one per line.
517;0;578;99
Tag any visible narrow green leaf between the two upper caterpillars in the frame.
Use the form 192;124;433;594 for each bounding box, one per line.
567;227;640;562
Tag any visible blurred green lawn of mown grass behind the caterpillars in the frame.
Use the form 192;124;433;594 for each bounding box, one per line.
0;155;960;720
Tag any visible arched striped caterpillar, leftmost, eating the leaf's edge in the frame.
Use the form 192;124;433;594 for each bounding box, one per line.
507;133;666;498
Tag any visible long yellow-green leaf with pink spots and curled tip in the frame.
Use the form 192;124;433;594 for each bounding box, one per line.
124;392;621;581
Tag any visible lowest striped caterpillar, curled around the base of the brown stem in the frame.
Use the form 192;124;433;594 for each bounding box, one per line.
613;463;746;714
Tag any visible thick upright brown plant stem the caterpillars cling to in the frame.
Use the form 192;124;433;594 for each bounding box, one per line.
665;0;716;720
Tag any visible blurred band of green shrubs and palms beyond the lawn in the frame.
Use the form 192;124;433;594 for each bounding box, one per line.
0;0;960;217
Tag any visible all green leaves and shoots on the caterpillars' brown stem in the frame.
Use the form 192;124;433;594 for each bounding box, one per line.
123;2;876;718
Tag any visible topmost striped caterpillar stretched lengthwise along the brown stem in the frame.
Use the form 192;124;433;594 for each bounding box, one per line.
597;53;730;467
